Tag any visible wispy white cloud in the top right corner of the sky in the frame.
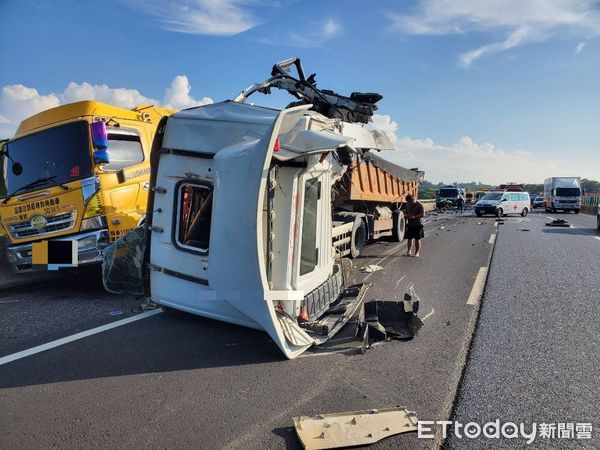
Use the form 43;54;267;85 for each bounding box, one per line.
388;0;600;67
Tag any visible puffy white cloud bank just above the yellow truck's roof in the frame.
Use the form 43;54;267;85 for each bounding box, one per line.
0;75;212;138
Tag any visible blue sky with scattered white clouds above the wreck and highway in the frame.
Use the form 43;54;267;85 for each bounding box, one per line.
0;0;600;183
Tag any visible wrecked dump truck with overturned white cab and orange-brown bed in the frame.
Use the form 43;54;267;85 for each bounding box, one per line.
104;59;423;358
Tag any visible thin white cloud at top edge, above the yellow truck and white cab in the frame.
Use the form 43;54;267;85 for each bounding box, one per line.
126;0;258;36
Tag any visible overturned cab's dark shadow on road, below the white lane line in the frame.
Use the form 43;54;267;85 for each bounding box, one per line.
0;311;285;389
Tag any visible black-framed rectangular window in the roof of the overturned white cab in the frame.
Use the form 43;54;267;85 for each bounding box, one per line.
175;183;212;252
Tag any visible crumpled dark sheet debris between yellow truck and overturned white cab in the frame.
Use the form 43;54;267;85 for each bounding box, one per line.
102;227;144;295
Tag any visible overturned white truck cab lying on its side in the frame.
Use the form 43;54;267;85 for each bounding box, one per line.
146;101;398;358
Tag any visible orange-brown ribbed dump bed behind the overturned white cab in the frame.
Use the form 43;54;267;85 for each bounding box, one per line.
342;152;423;203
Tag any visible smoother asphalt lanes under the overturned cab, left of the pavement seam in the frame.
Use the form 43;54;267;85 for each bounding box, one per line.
0;209;600;449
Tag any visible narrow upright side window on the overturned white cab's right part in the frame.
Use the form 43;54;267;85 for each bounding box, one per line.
300;178;321;275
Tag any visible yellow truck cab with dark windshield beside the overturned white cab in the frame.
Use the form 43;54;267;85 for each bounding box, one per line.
0;101;174;272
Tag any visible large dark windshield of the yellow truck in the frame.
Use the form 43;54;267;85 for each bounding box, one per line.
0;121;92;193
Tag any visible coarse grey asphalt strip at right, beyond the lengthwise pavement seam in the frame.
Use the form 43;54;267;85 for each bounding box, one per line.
448;213;600;448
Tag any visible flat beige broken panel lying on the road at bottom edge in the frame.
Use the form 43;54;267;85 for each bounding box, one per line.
294;407;418;450
